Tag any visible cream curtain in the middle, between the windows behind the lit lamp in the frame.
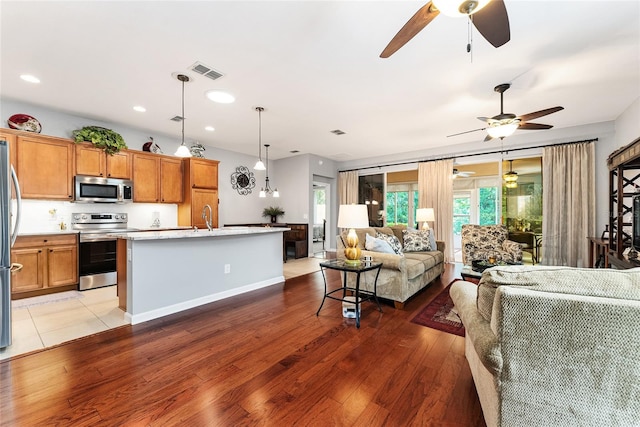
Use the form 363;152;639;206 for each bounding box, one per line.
418;159;454;262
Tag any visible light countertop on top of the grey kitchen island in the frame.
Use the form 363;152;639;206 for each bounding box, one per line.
109;227;290;240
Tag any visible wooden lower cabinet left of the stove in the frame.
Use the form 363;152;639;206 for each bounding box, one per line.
11;234;78;294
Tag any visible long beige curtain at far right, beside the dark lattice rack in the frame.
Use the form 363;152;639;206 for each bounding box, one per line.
542;142;596;267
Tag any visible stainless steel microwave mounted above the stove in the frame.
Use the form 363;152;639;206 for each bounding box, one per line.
74;175;133;203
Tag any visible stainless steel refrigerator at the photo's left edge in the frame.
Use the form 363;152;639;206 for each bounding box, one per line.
0;141;21;348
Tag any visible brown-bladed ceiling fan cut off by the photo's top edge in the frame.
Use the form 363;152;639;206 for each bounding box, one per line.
380;0;511;58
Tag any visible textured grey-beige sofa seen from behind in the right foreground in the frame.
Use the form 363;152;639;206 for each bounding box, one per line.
450;266;640;427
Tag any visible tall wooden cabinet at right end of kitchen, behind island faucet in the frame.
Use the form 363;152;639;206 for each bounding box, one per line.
178;157;219;228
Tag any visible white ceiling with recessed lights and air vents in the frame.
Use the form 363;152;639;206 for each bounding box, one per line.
0;0;640;160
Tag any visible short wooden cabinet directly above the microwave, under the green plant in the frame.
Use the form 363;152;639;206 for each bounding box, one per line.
75;143;131;179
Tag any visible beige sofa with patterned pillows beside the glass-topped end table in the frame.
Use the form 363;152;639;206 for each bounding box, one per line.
336;227;444;309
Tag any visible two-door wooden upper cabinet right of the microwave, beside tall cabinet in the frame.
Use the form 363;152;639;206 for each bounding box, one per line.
132;152;182;203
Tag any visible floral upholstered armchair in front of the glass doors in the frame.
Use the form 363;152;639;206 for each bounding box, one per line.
462;224;522;265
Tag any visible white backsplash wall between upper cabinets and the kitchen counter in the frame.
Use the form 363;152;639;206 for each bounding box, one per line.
17;200;178;233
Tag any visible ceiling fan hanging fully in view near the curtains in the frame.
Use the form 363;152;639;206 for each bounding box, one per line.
447;83;564;141
